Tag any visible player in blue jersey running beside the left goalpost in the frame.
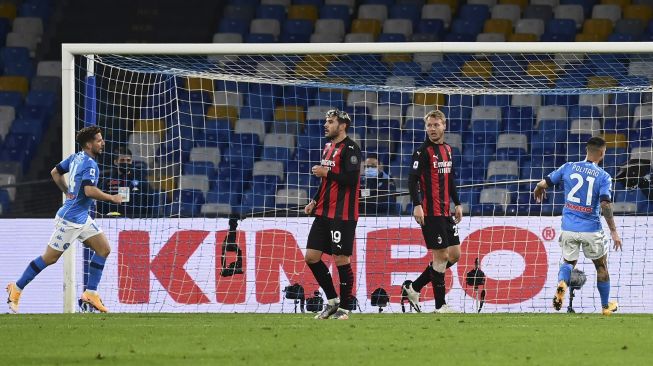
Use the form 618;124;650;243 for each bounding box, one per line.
7;126;122;313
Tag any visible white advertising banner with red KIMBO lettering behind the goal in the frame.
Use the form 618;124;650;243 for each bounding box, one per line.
0;216;653;313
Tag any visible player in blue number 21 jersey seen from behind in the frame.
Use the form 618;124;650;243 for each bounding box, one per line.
533;137;621;315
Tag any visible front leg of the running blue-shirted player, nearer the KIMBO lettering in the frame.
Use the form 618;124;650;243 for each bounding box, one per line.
80;218;111;313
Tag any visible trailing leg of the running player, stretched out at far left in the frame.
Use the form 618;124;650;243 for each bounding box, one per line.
7;219;73;313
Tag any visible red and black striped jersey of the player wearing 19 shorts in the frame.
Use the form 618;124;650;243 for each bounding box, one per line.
313;137;362;220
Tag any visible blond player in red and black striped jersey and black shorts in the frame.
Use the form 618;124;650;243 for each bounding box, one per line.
404;110;463;313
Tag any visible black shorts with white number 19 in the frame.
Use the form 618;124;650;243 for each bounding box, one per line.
306;216;356;256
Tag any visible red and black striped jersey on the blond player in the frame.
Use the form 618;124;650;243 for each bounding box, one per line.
408;138;460;216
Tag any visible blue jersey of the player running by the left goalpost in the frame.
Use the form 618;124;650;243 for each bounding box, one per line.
57;151;100;224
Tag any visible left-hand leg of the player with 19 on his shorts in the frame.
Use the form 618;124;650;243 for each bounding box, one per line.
304;217;340;319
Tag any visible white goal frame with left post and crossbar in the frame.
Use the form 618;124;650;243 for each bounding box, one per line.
61;42;653;313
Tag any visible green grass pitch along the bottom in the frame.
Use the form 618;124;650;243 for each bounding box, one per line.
0;314;653;366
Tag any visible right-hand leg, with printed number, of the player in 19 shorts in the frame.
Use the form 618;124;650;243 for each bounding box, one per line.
331;220;356;320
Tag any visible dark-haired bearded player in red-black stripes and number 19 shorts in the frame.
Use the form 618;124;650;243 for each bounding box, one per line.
304;109;361;320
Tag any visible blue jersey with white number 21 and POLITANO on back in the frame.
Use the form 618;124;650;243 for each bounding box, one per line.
547;161;612;232
